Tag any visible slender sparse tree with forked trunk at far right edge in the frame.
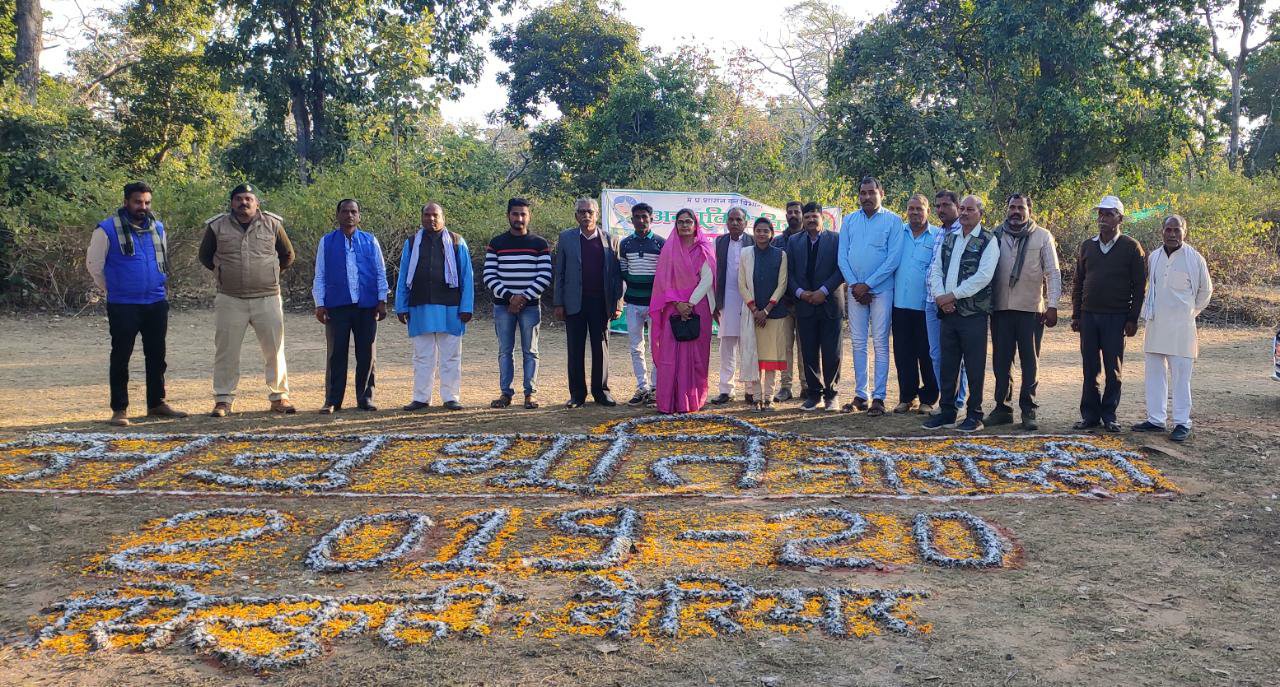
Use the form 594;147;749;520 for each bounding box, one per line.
1199;0;1280;171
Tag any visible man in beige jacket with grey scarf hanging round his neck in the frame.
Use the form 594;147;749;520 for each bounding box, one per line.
987;193;1062;431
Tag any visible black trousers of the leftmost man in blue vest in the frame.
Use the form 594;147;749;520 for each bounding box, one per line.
106;301;169;411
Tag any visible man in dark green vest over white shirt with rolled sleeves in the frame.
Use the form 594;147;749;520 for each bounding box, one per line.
923;196;1000;432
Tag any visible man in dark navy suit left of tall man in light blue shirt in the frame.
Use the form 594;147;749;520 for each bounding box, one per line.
787;202;845;412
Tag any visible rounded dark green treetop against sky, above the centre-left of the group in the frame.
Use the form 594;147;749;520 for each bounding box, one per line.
490;0;643;125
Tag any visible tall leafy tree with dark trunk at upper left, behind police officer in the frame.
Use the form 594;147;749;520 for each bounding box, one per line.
207;0;512;183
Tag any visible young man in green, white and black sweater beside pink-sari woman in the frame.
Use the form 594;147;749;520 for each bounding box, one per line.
618;202;664;406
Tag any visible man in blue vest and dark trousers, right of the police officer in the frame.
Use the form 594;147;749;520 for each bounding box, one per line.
311;198;388;415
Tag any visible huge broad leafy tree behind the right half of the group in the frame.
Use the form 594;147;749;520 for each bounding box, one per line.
822;0;1198;191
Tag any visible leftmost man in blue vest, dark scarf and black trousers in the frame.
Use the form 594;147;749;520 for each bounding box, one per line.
84;182;187;427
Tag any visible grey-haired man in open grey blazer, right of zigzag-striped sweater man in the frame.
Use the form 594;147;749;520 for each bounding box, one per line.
553;198;622;408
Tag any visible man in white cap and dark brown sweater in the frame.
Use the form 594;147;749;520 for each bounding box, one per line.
1071;196;1147;431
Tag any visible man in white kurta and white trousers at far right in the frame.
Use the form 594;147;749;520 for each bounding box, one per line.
1133;215;1213;441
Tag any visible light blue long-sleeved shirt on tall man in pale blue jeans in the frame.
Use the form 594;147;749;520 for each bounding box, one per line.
840;207;902;293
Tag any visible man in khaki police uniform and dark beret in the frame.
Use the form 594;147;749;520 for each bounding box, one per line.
200;184;297;417
